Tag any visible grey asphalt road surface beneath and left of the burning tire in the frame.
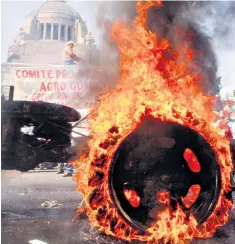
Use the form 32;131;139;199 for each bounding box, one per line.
1;170;235;244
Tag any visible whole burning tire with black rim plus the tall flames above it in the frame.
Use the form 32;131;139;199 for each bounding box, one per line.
75;1;233;243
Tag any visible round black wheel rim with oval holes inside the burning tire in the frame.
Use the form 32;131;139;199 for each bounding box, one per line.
109;118;221;231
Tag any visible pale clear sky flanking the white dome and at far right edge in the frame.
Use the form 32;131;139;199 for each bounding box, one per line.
1;0;235;95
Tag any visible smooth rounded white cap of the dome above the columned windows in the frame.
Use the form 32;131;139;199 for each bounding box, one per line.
35;0;81;22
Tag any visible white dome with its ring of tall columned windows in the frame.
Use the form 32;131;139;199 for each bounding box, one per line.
25;0;88;43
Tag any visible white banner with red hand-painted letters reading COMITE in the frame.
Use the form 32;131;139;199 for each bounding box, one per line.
11;65;95;109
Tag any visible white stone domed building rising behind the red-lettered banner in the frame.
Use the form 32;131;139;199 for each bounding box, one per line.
7;0;94;64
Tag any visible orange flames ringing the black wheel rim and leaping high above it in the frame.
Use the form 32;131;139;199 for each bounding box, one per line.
75;1;233;243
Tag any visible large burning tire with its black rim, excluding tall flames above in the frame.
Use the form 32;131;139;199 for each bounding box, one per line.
81;108;232;242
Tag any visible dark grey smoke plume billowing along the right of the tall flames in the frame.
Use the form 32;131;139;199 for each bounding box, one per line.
148;2;218;94
